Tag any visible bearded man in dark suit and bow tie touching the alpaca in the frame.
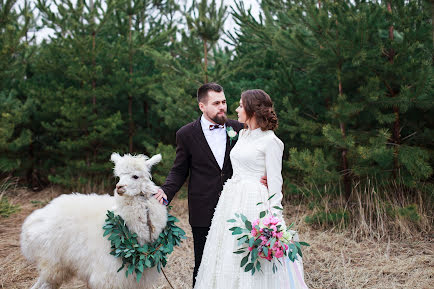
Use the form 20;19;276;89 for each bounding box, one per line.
155;83;243;286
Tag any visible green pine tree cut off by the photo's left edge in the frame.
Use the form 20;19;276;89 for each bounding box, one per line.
0;0;34;176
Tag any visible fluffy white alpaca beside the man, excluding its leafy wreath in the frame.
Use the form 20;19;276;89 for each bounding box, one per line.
21;153;167;289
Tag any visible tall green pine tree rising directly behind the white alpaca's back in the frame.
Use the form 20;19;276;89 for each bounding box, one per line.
37;0;122;188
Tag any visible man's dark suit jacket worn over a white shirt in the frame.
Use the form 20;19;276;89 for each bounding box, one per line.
161;118;243;227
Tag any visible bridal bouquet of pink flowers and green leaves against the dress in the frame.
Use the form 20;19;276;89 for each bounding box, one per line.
228;195;309;275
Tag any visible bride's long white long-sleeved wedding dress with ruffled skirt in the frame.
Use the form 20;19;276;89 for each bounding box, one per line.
194;128;307;289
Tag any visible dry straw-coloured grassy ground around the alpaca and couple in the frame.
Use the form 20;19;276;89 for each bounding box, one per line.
0;188;434;289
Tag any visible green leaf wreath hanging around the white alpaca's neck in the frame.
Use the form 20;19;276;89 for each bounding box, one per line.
103;211;186;283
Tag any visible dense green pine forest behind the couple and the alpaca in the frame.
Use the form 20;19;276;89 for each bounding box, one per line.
0;0;434;238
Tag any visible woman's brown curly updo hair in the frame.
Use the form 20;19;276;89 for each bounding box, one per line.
241;89;278;131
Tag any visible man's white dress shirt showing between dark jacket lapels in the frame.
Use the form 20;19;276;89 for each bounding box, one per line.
200;115;226;169
